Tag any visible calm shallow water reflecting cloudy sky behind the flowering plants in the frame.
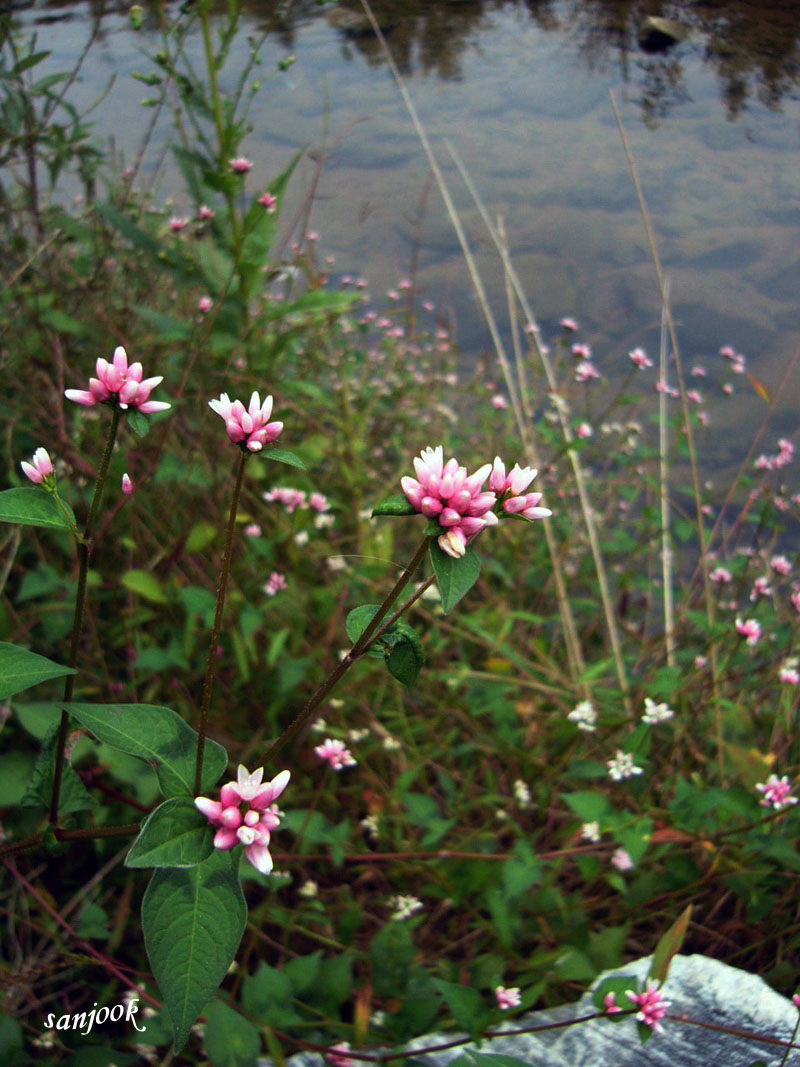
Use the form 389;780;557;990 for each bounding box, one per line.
7;0;800;471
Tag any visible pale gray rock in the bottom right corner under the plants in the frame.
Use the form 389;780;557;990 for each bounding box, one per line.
267;956;800;1067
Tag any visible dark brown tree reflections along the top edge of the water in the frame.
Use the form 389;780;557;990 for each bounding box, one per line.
17;0;800;125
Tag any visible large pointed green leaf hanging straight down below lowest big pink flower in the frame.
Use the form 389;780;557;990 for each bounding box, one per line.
142;848;247;1053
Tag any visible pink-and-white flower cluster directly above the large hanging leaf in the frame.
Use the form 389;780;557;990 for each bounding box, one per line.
194;764;289;874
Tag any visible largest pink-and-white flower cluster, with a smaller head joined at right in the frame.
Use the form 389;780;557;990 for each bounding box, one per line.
400;445;551;559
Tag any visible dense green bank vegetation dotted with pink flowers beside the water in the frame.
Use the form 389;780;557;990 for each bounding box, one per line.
0;0;800;1067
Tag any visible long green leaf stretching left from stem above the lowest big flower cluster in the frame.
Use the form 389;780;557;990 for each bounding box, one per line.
61;703;228;797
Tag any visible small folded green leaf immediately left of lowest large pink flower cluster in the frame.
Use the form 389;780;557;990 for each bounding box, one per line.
125;797;214;867
